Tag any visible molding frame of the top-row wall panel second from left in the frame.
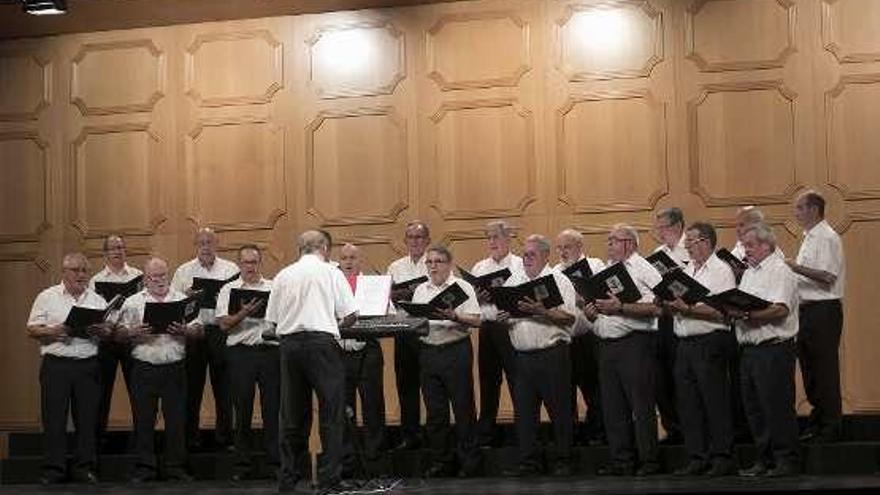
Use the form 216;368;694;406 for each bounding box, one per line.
70;39;165;116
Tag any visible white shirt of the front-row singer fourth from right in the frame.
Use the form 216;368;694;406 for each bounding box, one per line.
504;265;578;351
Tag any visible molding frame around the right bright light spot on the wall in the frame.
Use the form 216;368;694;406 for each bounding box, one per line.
555;0;664;82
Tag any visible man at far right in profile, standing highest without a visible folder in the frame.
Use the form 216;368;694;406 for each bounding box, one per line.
786;191;846;442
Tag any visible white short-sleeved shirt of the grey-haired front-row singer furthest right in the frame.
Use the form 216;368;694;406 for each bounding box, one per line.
736;254;798;344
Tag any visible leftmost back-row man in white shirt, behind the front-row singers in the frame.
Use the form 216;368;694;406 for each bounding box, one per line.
89;234;142;446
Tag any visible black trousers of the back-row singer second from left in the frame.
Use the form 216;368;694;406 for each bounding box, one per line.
186;325;232;444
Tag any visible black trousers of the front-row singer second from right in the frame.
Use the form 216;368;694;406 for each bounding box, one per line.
675;329;733;462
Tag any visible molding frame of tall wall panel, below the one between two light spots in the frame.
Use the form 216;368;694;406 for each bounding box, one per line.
428;98;538;220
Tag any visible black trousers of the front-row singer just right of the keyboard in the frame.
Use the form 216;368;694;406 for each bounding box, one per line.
421;338;479;471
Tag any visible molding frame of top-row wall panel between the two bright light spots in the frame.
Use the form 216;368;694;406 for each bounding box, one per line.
425;11;531;91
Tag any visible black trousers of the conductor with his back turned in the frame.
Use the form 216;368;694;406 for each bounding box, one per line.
279;332;345;486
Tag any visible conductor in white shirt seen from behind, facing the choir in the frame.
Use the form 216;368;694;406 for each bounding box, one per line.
266;230;357;492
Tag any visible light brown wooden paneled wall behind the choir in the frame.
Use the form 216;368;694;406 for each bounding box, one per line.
0;0;880;429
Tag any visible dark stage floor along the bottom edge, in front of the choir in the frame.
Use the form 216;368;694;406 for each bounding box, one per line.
0;475;880;495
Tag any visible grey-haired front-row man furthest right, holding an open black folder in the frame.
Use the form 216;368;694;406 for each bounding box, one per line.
728;224;800;477
